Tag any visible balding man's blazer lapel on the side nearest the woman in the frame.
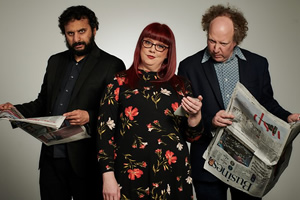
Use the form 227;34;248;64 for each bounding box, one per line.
203;59;224;109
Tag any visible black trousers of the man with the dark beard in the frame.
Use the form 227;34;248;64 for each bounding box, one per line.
40;157;102;200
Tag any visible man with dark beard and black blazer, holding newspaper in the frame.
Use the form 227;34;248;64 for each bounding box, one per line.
0;6;125;200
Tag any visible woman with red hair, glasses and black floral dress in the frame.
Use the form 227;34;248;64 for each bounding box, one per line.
97;23;202;200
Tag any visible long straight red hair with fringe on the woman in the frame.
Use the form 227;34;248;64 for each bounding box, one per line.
126;22;182;87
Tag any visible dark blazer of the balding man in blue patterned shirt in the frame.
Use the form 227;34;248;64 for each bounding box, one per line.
178;49;291;181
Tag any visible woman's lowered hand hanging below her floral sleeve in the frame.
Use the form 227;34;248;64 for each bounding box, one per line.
102;172;121;200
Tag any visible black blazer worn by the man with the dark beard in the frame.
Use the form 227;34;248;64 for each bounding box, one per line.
16;45;125;176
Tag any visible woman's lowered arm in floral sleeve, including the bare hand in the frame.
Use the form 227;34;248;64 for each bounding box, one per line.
96;76;120;199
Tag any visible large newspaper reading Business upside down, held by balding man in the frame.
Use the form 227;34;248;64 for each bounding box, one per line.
203;83;300;197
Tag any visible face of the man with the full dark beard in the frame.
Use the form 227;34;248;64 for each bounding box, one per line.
65;18;96;57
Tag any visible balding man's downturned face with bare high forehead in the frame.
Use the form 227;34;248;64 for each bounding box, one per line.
207;17;236;62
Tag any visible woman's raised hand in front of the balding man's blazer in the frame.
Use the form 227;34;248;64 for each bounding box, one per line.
181;95;203;127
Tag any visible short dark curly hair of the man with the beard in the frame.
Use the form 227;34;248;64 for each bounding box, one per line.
58;5;99;35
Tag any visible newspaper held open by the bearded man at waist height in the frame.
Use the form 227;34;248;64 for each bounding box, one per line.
0;108;90;146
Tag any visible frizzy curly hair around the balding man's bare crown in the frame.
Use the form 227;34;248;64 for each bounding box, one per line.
201;5;248;45
